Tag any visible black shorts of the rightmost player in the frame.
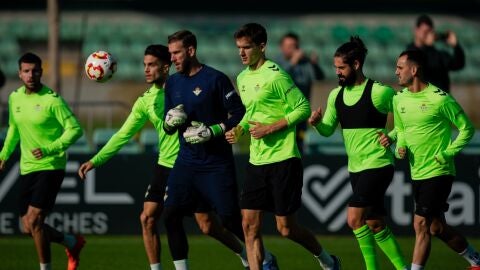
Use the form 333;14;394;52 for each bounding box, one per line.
412;175;454;217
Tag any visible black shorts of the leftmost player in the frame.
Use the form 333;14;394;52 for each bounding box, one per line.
19;170;65;216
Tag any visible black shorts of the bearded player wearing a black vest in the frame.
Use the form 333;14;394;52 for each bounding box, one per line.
348;165;394;219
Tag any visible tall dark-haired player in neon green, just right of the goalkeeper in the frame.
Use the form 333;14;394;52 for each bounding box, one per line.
225;23;340;270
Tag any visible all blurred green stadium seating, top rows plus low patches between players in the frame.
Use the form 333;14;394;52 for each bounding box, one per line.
0;14;480;154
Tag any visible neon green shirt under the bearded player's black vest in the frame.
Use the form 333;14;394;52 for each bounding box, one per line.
315;79;395;172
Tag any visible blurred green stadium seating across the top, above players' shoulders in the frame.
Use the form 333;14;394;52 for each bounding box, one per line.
0;16;480;82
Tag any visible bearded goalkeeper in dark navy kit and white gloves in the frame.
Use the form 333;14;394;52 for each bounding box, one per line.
163;30;277;270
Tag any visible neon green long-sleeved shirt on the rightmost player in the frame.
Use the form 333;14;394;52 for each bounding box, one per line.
393;84;475;180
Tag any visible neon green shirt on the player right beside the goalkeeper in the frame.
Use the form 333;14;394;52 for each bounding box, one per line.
237;60;310;165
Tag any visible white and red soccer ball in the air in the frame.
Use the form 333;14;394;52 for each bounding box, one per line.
85;51;117;82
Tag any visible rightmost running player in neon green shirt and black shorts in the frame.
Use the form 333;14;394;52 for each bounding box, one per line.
393;50;480;270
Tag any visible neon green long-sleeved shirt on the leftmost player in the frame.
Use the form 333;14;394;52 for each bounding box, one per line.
0;86;83;175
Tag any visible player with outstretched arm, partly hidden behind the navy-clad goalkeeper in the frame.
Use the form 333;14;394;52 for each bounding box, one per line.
78;44;255;270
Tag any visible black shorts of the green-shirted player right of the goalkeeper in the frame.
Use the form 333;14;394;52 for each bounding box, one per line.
240;158;303;216
